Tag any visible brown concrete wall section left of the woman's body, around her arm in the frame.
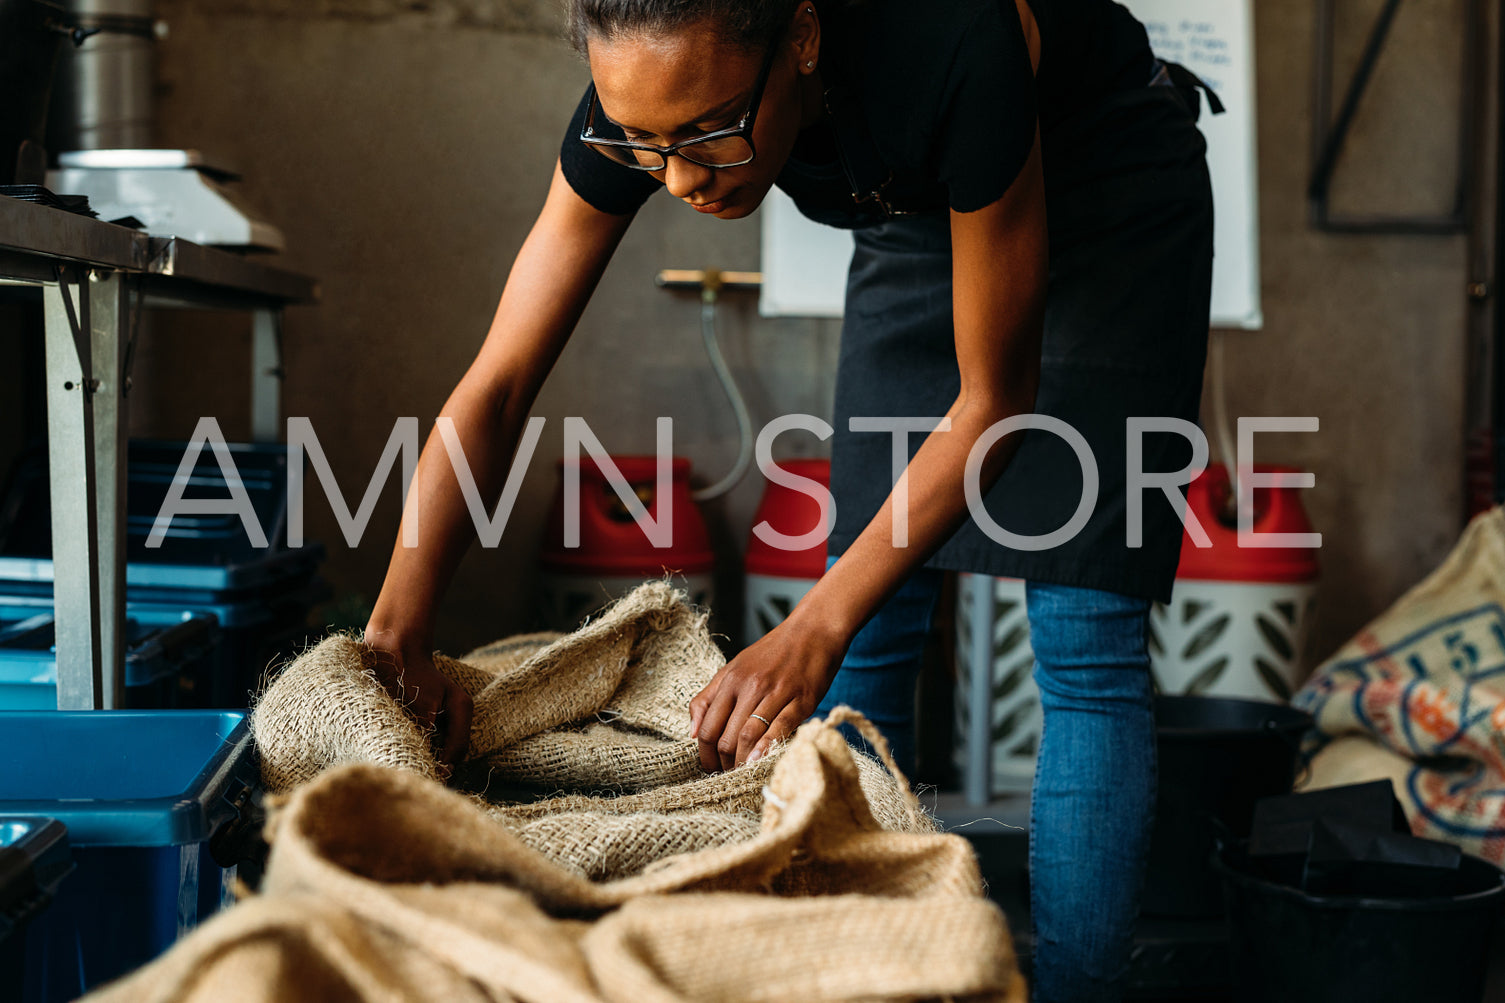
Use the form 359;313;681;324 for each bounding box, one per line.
132;0;838;648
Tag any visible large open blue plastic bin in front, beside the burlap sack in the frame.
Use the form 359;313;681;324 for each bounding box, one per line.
0;711;260;1003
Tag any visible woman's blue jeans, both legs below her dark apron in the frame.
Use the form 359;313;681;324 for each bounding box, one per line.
820;569;1156;1003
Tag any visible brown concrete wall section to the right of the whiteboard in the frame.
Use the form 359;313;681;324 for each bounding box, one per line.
1204;0;1490;658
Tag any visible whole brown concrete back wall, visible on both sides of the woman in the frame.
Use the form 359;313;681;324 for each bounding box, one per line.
134;0;1492;668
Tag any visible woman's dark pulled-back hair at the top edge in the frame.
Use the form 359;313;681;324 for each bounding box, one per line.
564;0;820;56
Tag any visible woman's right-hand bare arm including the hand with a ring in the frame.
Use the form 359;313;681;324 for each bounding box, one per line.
691;136;1049;770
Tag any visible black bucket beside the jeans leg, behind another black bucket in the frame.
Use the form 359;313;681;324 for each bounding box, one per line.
1141;696;1312;919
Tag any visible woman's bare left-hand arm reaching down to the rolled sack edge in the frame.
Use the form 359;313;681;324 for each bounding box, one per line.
366;164;632;764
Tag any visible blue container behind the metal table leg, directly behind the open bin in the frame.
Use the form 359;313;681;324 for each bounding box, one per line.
0;596;217;711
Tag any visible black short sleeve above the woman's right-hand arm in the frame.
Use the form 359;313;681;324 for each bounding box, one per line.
935;0;1038;212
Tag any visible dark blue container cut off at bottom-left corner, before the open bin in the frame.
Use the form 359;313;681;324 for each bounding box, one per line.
0;816;74;1000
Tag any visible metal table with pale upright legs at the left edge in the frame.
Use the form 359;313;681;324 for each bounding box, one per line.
0;196;319;709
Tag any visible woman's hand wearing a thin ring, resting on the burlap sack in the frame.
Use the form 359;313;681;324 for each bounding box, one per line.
689;620;847;773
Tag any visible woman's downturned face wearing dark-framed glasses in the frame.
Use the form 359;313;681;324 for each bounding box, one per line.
588;8;820;220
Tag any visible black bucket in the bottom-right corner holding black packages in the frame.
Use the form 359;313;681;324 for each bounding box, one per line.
1215;846;1505;1003
